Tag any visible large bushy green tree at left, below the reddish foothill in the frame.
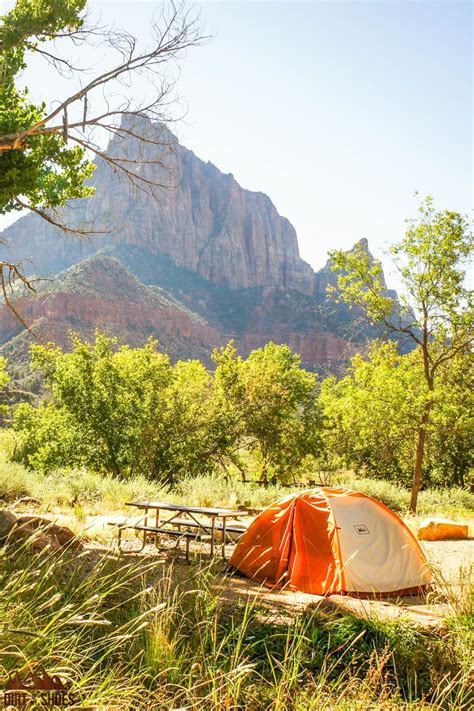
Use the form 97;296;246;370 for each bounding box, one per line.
20;333;171;476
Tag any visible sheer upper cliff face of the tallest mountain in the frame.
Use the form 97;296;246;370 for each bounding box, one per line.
2;119;314;293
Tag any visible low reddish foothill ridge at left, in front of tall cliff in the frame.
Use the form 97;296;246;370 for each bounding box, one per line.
0;256;222;362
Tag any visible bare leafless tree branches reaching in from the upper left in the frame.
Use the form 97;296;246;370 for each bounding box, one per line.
0;2;208;335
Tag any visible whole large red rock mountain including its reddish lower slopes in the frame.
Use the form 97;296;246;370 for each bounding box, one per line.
0;119;386;371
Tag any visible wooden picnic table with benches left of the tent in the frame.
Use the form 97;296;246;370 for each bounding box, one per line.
113;501;245;559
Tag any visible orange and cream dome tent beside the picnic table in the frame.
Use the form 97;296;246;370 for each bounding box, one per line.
230;488;431;595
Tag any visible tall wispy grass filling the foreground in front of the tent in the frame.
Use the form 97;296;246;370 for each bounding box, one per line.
0;544;472;711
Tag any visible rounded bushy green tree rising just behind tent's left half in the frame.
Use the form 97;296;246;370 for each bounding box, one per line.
213;343;321;483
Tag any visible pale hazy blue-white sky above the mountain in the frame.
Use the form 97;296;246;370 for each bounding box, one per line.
4;1;473;278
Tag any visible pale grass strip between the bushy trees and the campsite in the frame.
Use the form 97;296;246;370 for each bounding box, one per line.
0;459;474;520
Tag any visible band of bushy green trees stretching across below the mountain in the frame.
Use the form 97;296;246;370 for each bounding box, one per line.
0;332;474;486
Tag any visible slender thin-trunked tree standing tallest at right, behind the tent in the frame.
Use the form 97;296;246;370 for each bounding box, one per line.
330;198;474;511
